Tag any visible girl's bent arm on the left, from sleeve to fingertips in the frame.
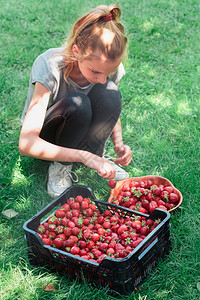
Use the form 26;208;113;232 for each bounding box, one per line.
19;82;115;178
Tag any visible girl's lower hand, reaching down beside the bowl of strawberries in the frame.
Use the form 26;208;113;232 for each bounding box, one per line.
83;152;116;179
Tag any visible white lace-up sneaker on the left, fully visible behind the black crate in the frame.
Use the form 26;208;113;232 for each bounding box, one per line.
47;162;78;198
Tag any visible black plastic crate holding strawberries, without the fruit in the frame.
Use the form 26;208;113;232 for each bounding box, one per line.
23;185;170;295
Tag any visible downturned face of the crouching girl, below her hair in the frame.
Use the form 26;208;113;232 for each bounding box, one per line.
73;45;122;84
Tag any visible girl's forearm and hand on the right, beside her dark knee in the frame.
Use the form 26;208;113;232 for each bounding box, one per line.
111;119;132;167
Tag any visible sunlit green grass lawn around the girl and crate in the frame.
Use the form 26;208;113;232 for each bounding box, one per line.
0;0;200;300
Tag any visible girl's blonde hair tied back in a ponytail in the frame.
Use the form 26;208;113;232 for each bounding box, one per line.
62;4;127;81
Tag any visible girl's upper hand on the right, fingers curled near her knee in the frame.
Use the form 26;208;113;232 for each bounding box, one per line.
114;145;132;167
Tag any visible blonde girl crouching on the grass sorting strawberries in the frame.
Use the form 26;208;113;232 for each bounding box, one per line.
19;4;132;197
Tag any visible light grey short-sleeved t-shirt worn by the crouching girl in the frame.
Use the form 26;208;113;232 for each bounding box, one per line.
21;48;125;124
